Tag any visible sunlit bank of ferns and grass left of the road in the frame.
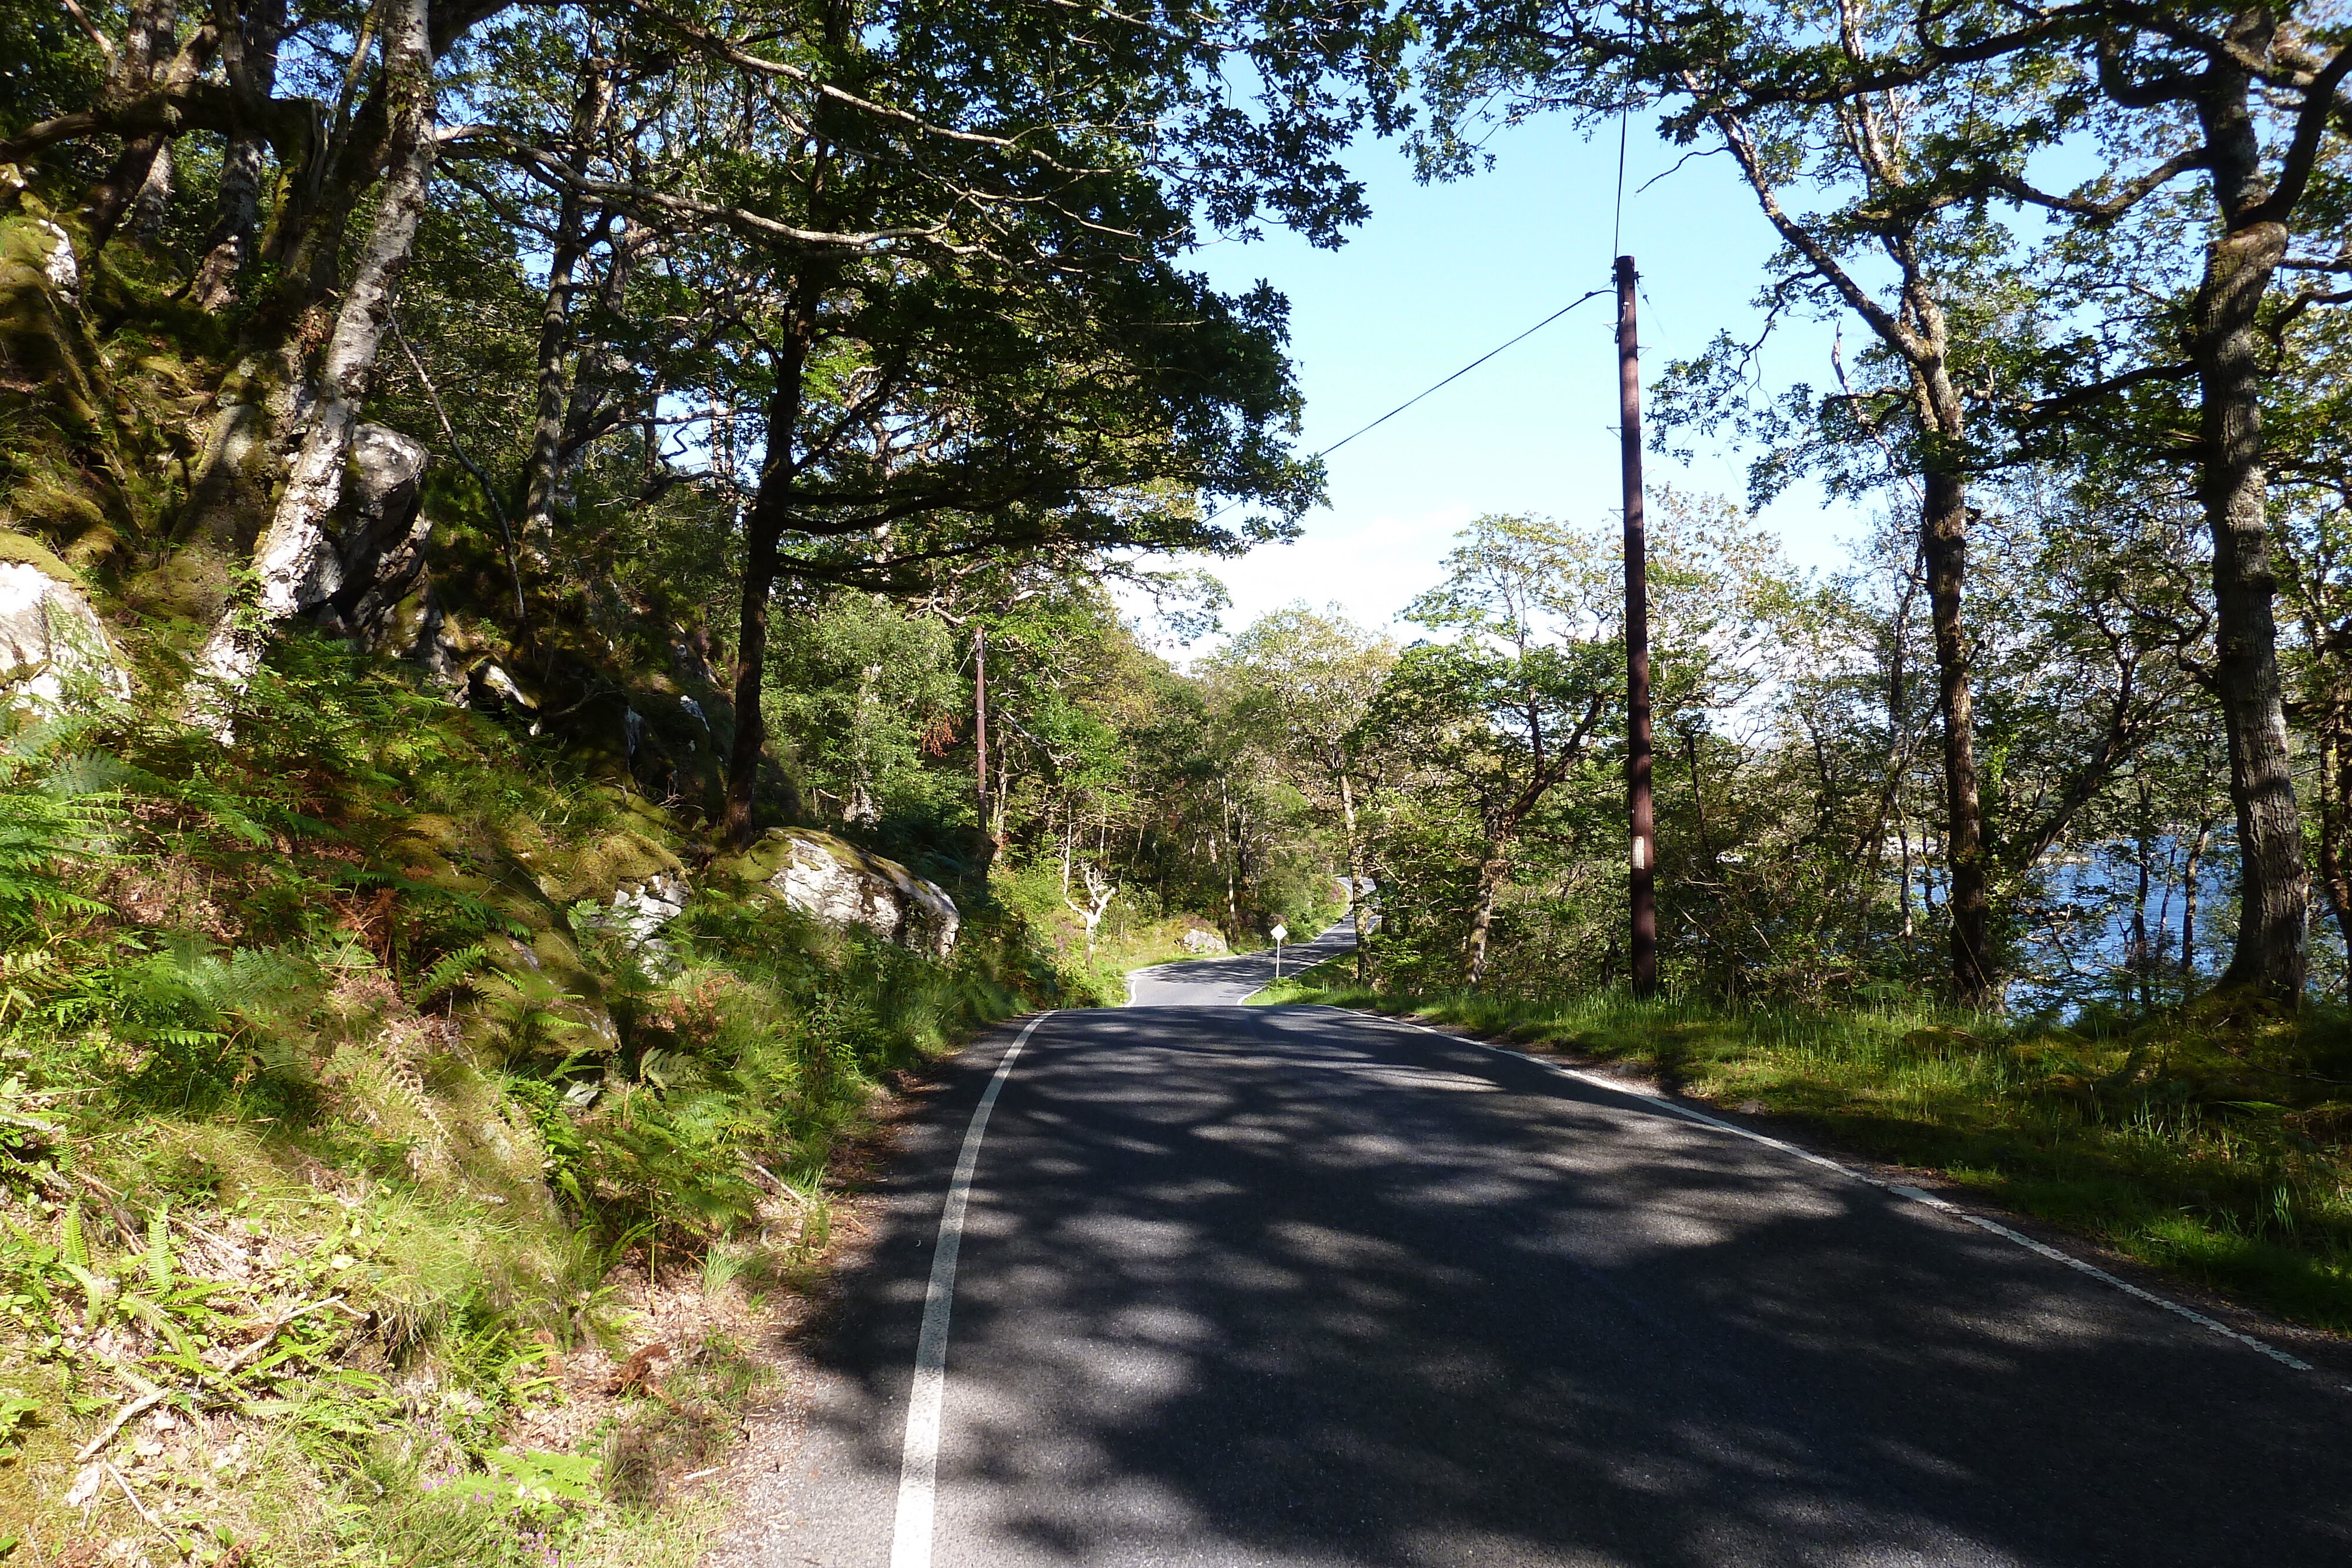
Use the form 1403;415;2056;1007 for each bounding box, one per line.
0;637;1065;1568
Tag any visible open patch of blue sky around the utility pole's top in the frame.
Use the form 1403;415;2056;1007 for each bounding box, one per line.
1148;111;1863;630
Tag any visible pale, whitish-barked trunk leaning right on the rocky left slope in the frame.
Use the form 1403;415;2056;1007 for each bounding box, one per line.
188;0;435;738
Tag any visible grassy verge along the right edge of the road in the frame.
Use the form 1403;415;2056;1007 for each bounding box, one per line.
1256;964;2352;1333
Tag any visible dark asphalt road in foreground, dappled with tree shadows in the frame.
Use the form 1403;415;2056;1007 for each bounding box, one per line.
720;938;2352;1568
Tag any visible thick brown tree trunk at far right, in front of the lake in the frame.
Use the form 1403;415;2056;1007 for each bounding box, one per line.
2187;24;2310;1004
